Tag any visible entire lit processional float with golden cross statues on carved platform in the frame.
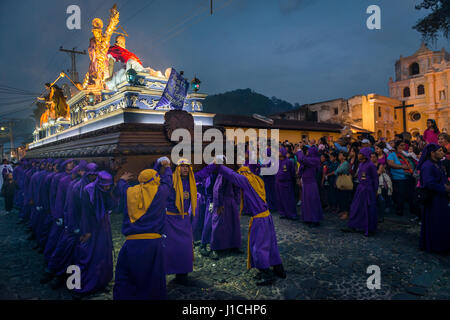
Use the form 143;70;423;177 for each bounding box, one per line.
27;5;214;175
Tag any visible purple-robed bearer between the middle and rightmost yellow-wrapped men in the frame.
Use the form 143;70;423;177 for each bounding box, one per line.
211;174;241;250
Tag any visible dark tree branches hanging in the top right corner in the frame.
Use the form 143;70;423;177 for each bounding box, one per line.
413;0;450;43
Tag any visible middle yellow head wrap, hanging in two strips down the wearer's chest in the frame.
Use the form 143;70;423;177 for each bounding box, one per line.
172;159;197;218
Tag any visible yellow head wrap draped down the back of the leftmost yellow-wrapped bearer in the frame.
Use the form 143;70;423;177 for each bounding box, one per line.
127;169;160;223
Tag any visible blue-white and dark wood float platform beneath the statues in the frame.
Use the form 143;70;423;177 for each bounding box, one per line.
26;73;215;172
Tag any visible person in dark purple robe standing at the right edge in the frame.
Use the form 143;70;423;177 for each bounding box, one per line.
419;160;450;253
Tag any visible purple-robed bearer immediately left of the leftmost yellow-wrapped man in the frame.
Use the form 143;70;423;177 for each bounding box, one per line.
74;171;115;294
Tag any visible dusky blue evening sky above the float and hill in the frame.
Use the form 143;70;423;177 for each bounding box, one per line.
0;0;450;144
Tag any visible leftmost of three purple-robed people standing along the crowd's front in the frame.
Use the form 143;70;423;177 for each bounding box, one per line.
275;148;297;218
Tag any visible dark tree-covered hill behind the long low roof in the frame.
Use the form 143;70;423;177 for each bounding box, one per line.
203;89;298;116
